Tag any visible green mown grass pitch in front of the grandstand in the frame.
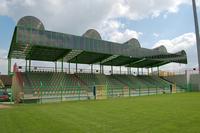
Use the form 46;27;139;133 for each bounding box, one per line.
0;93;200;133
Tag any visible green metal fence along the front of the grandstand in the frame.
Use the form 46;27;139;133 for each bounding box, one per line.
17;82;189;103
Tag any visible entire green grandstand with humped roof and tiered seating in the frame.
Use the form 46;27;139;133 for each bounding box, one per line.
8;16;187;103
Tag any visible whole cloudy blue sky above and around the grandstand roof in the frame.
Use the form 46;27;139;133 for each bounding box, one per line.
0;0;200;73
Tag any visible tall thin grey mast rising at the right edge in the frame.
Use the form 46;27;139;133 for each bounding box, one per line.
192;0;200;73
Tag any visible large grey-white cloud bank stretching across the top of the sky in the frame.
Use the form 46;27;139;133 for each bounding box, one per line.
0;0;191;34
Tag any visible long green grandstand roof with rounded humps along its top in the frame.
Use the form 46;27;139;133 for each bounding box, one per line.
8;16;187;67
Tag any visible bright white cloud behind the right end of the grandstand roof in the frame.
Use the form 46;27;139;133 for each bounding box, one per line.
153;33;197;71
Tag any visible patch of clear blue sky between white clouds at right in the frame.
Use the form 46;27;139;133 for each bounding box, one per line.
114;5;197;48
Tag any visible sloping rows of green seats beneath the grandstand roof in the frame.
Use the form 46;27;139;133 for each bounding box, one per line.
22;72;170;94
